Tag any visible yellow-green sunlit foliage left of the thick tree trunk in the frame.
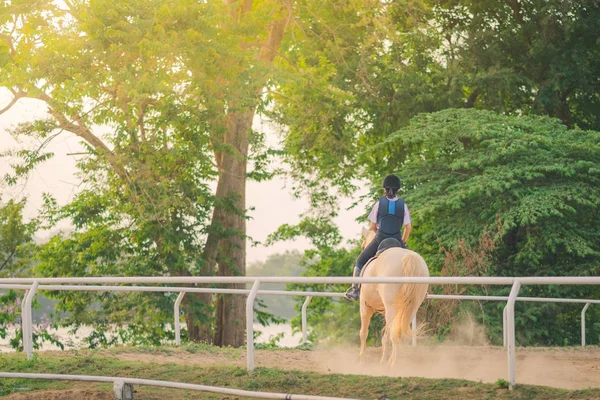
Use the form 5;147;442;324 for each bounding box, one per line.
0;0;284;346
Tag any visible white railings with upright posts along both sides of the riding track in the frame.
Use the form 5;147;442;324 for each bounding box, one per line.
0;277;600;389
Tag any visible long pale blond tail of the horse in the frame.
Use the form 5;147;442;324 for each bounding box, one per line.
386;252;429;340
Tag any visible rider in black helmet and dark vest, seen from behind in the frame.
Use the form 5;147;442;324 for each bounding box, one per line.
344;174;411;301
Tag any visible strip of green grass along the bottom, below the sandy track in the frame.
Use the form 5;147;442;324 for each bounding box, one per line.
0;345;600;400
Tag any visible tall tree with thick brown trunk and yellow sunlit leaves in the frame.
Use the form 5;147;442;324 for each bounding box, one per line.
2;0;428;344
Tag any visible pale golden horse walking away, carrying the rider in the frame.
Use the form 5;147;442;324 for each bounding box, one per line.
360;228;429;366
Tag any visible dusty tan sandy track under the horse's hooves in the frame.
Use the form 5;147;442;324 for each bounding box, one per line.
113;346;600;389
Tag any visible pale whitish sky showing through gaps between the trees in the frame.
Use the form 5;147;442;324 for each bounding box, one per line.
0;88;363;265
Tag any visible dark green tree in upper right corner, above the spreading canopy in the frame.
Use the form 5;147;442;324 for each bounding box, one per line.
435;0;600;131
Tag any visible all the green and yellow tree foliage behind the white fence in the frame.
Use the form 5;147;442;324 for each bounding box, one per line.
0;0;600;345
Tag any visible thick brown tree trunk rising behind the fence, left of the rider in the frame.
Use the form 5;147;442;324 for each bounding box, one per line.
212;0;291;347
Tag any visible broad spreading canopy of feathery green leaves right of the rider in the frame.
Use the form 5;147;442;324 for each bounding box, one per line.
380;110;600;268
